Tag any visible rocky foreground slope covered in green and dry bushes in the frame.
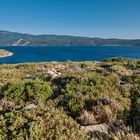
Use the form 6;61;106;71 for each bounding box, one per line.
0;58;140;140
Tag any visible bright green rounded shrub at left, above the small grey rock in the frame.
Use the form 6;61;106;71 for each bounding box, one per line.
1;80;52;106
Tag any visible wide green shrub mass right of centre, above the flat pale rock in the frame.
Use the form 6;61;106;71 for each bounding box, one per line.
58;71;130;123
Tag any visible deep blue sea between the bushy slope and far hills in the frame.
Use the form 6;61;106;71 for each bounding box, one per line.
0;46;140;64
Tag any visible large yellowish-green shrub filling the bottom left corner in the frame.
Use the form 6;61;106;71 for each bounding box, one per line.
0;104;86;140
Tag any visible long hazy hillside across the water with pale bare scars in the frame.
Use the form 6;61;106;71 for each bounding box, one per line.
0;31;140;46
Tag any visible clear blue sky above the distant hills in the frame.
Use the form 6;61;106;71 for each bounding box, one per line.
0;0;140;39
